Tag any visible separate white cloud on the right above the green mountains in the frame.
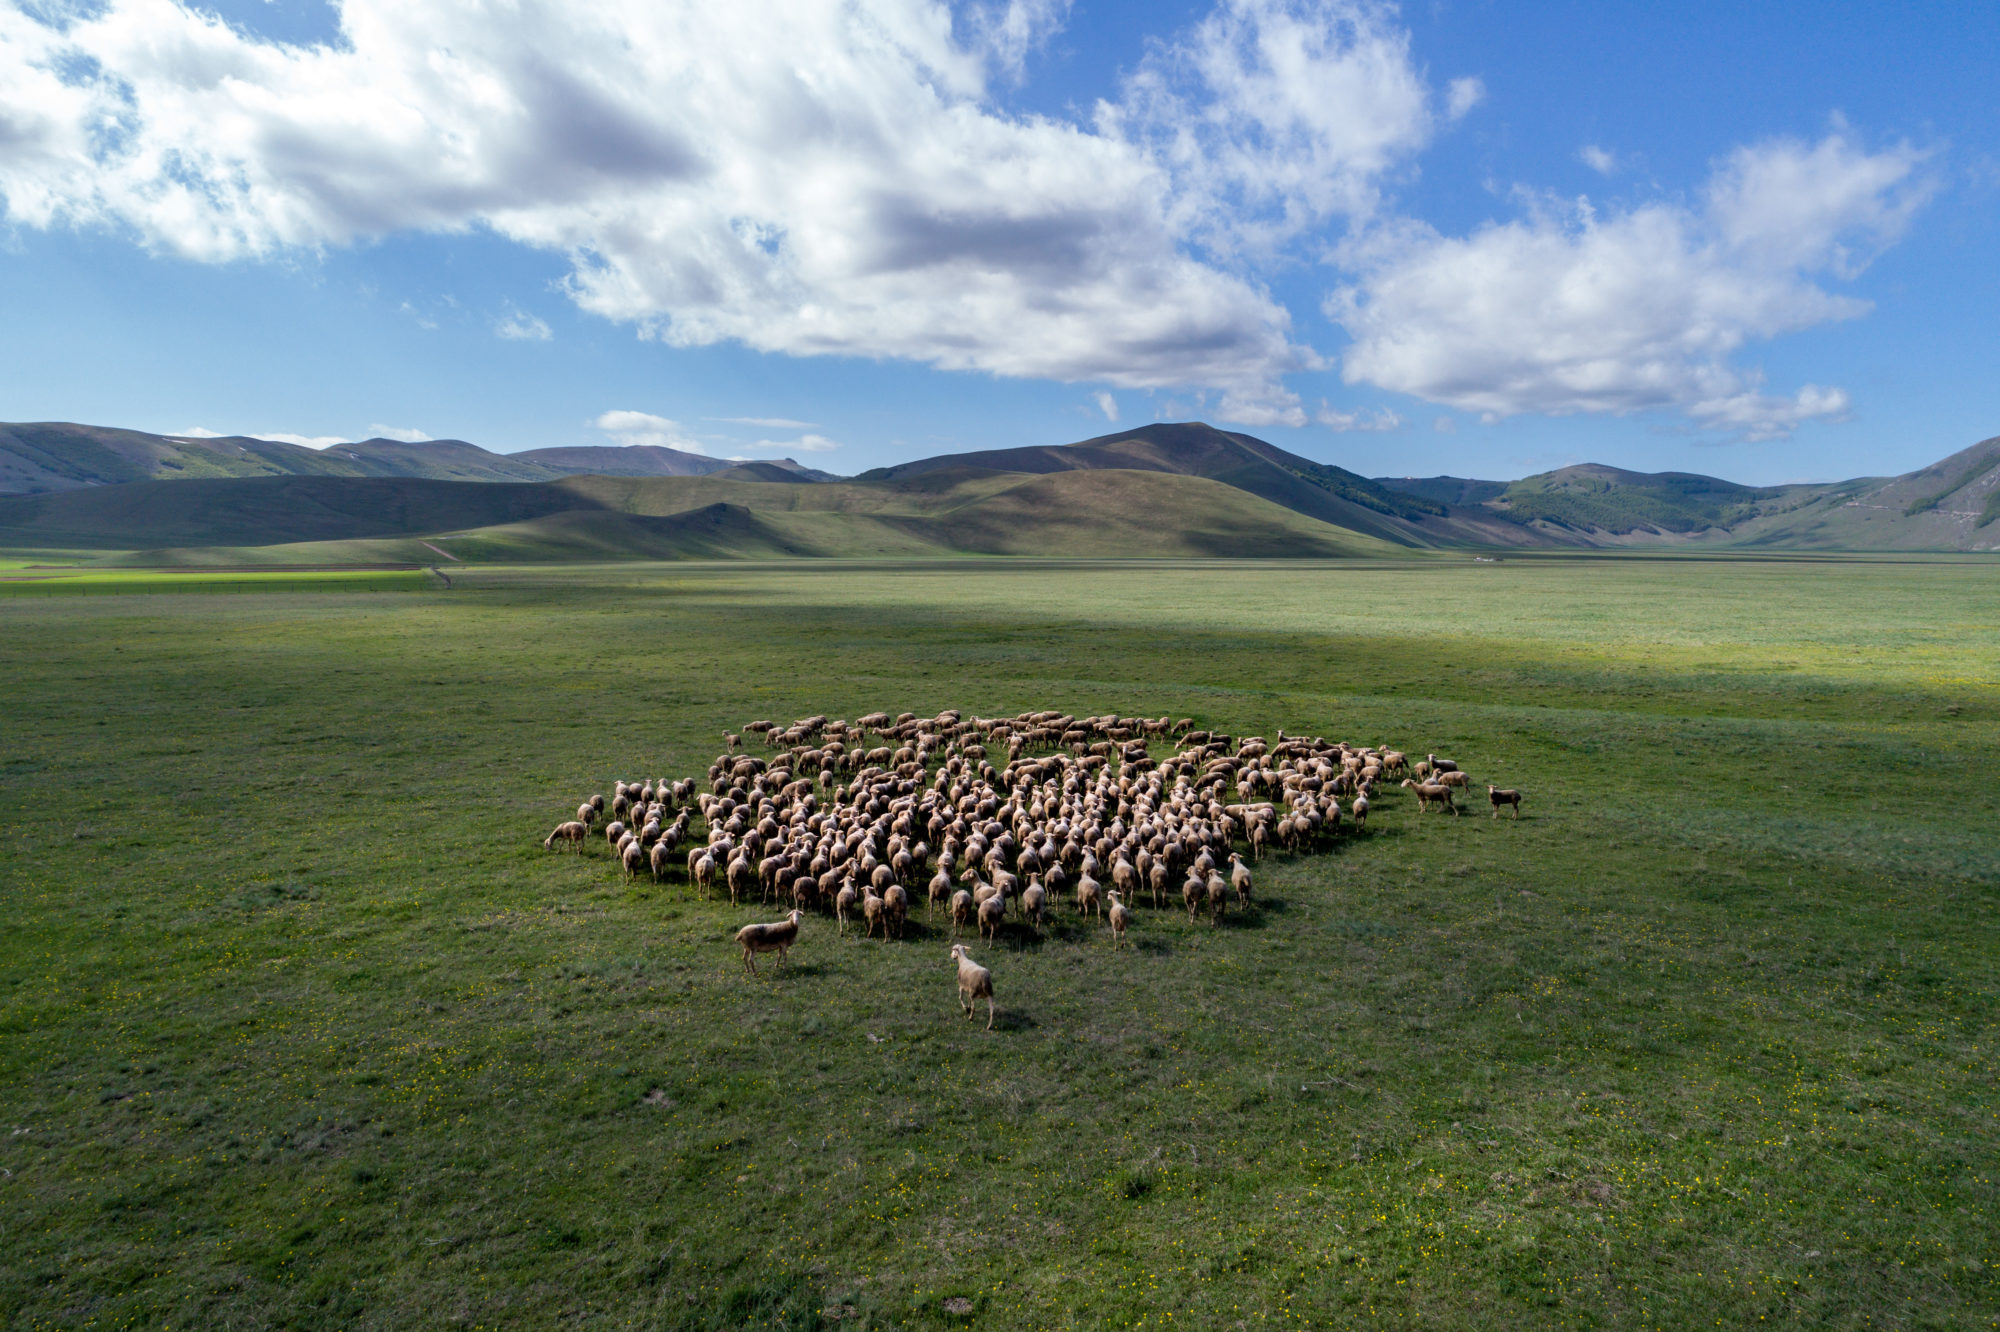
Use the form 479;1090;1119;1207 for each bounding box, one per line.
1326;130;1928;438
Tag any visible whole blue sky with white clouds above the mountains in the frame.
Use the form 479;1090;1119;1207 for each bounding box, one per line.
0;0;2000;482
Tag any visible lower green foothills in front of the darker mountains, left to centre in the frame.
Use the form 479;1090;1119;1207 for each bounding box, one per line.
0;468;1398;564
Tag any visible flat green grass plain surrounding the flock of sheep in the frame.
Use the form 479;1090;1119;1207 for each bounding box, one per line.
0;558;2000;1328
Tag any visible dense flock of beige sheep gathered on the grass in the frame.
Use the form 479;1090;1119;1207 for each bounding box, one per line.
542;710;1522;1030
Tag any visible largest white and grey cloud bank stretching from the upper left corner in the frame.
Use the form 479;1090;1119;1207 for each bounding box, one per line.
0;0;1436;410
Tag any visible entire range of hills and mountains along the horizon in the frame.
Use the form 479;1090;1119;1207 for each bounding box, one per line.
0;422;2000;564
